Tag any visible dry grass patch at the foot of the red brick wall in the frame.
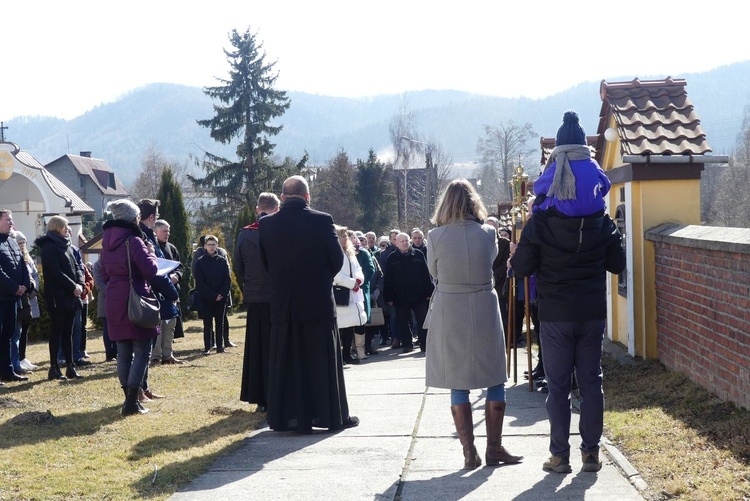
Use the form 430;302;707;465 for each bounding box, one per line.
603;357;750;501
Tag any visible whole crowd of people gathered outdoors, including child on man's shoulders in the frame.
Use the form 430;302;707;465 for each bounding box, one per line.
0;112;625;473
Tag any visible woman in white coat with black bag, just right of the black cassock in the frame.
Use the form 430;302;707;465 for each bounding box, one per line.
333;225;367;364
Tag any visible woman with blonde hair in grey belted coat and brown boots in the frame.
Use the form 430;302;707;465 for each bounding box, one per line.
426;179;523;469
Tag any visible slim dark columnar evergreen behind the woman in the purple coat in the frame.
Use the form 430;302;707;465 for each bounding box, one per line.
156;167;193;305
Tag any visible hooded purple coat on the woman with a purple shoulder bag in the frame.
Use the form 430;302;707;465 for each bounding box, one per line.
99;219;158;341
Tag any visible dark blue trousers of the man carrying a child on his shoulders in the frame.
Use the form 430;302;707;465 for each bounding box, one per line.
541;320;605;457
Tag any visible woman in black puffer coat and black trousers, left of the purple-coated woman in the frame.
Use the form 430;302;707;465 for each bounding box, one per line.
35;216;85;380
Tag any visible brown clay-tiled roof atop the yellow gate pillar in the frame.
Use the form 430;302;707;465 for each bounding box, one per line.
597;77;712;155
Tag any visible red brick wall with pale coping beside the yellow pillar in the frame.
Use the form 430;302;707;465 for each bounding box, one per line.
646;224;750;408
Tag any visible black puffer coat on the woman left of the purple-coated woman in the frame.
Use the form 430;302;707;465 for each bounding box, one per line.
34;231;85;311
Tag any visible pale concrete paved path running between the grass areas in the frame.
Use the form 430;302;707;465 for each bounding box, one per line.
170;349;643;501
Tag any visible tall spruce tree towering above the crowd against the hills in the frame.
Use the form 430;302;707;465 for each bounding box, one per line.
190;28;289;234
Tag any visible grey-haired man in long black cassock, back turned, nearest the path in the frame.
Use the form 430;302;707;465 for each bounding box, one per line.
258;176;359;434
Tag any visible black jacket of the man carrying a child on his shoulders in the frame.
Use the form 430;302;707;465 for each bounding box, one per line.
510;209;625;322
